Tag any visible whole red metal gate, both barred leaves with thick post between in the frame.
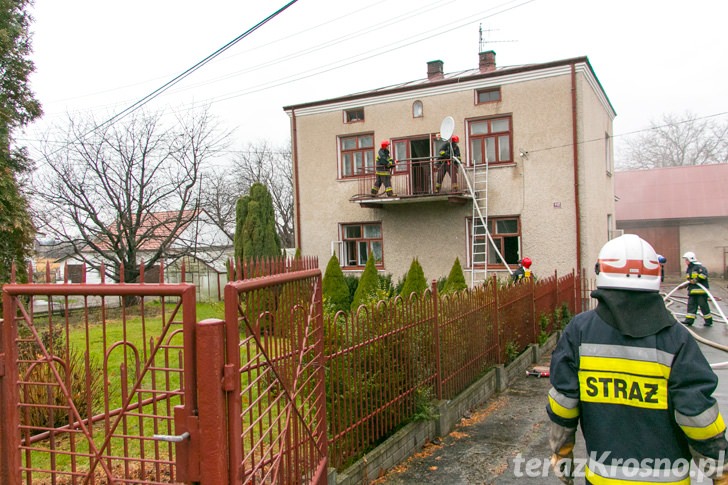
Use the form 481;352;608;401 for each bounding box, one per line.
0;263;327;485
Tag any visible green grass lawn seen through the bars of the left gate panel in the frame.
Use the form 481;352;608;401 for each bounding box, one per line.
23;302;224;483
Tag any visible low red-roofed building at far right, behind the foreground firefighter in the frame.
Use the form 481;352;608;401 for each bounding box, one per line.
615;163;728;278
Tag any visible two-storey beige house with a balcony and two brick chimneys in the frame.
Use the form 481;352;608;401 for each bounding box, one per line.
284;51;616;284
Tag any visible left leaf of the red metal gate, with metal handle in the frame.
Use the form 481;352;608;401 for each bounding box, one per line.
0;266;197;485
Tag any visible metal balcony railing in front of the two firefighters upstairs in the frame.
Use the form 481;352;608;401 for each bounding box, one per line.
351;157;470;204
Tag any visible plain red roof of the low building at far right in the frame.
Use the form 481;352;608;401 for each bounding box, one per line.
614;163;728;221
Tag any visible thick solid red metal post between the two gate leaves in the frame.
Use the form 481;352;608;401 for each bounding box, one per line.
196;318;229;485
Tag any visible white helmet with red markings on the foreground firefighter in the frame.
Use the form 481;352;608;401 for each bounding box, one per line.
596;234;660;291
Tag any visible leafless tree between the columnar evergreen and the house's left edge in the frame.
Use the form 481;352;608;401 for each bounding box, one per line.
230;141;295;248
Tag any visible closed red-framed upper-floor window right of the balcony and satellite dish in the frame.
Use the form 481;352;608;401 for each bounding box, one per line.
468;116;513;165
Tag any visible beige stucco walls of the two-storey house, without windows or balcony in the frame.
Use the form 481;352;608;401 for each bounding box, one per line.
292;58;614;280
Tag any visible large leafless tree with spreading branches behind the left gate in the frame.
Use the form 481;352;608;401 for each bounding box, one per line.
36;109;228;282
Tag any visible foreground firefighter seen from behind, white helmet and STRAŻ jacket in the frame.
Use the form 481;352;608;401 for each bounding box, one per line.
546;234;728;485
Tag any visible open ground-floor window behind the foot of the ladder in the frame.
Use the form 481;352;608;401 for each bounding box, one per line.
467;217;521;269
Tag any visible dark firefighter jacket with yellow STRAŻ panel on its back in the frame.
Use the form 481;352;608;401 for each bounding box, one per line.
547;311;725;485
